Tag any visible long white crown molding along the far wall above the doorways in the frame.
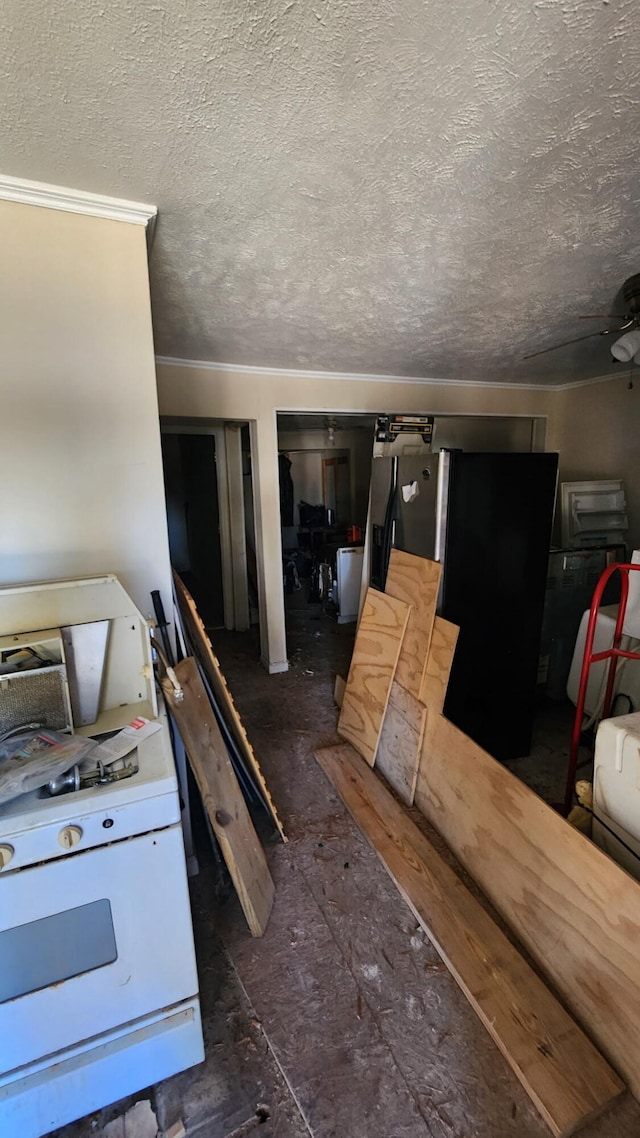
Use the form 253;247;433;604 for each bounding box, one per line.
156;356;622;393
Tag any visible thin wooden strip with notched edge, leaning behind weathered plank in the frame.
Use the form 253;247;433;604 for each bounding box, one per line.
173;570;287;842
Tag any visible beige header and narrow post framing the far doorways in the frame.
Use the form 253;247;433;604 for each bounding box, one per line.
157;362;557;671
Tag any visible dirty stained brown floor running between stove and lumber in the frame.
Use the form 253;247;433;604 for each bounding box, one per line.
48;597;640;1138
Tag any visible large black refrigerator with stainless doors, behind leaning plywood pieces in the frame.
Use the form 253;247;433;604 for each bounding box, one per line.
371;450;558;760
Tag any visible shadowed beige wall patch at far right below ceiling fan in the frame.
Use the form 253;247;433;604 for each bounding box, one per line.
553;370;640;549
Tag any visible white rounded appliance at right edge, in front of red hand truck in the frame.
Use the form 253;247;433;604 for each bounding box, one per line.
592;712;640;880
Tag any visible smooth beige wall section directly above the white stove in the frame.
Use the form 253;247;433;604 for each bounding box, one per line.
0;201;171;613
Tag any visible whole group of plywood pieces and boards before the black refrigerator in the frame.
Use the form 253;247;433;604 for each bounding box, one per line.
317;551;640;1135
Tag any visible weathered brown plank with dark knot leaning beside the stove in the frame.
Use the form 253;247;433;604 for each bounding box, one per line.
162;657;276;937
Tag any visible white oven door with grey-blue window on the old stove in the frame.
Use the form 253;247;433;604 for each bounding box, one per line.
0;826;198;1073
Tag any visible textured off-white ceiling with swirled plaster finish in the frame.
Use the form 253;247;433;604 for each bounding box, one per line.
0;0;640;382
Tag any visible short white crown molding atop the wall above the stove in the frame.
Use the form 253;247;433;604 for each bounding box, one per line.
0;174;158;225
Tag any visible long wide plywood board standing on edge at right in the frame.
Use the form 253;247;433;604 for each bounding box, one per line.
416;717;640;1097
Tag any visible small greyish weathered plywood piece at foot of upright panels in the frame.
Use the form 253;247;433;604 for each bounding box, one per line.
376;679;427;806
